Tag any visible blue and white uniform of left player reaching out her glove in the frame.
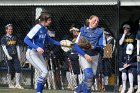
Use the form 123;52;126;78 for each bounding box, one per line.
24;24;60;93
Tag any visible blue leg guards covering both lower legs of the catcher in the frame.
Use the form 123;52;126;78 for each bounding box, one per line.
75;68;93;93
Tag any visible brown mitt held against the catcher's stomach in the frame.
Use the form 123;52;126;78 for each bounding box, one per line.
78;36;92;50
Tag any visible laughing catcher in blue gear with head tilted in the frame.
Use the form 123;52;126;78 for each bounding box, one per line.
74;15;105;93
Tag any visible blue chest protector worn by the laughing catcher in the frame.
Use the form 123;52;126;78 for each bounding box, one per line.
81;27;103;46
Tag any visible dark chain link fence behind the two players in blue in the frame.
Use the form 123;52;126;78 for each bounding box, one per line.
0;1;119;93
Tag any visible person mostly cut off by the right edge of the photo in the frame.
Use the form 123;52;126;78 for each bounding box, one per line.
136;31;140;93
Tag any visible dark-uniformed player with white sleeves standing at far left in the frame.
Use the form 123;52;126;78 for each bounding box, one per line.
1;24;23;89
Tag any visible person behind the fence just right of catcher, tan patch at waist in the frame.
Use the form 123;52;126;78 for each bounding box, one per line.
103;30;115;85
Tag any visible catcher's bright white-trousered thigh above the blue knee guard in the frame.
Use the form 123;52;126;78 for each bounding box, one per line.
79;55;91;70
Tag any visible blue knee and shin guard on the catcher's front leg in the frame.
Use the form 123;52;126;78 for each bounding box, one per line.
84;68;94;88
